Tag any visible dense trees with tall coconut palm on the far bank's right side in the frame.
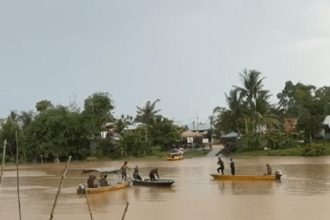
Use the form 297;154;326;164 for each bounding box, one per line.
213;70;330;155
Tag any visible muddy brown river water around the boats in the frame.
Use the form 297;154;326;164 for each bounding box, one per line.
0;157;330;220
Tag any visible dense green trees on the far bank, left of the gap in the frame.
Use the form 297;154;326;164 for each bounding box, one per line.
0;93;180;162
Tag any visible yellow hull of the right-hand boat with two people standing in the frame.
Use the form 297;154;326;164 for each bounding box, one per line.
211;174;281;181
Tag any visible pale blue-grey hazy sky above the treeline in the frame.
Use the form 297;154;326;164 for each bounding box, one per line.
0;0;330;123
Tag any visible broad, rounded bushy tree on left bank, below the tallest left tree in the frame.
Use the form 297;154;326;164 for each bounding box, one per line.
24;106;89;160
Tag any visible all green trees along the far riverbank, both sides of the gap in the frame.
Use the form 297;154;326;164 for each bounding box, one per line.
0;70;330;162
